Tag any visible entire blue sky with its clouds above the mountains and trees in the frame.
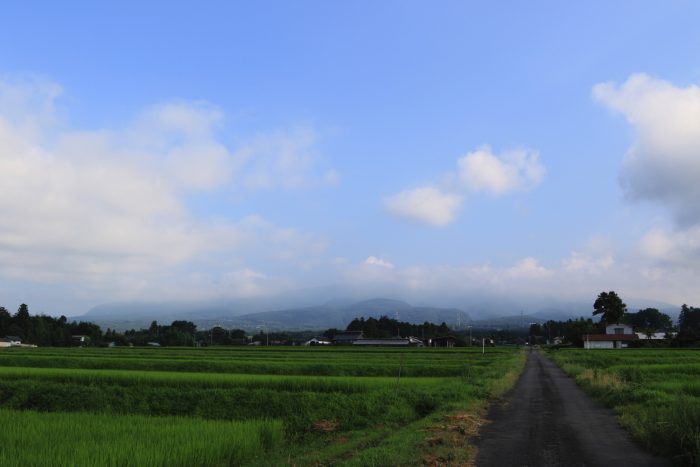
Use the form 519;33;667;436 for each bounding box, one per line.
0;1;700;313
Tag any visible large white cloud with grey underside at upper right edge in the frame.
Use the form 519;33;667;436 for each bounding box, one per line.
593;74;700;227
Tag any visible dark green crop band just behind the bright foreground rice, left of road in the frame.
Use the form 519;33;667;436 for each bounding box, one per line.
0;372;488;438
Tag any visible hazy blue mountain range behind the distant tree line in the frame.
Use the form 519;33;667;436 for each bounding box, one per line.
71;288;678;331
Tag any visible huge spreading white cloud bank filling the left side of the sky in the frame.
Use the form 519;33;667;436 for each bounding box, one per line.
0;77;325;300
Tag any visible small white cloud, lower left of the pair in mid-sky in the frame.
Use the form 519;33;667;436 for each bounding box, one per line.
384;186;462;227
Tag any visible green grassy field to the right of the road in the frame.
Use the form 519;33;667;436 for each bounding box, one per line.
549;349;700;466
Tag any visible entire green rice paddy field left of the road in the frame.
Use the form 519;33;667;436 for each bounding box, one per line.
0;347;524;466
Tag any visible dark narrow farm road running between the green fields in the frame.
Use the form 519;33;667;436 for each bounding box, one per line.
476;349;670;467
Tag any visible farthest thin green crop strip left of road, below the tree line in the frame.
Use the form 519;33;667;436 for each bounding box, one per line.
0;349;510;377
